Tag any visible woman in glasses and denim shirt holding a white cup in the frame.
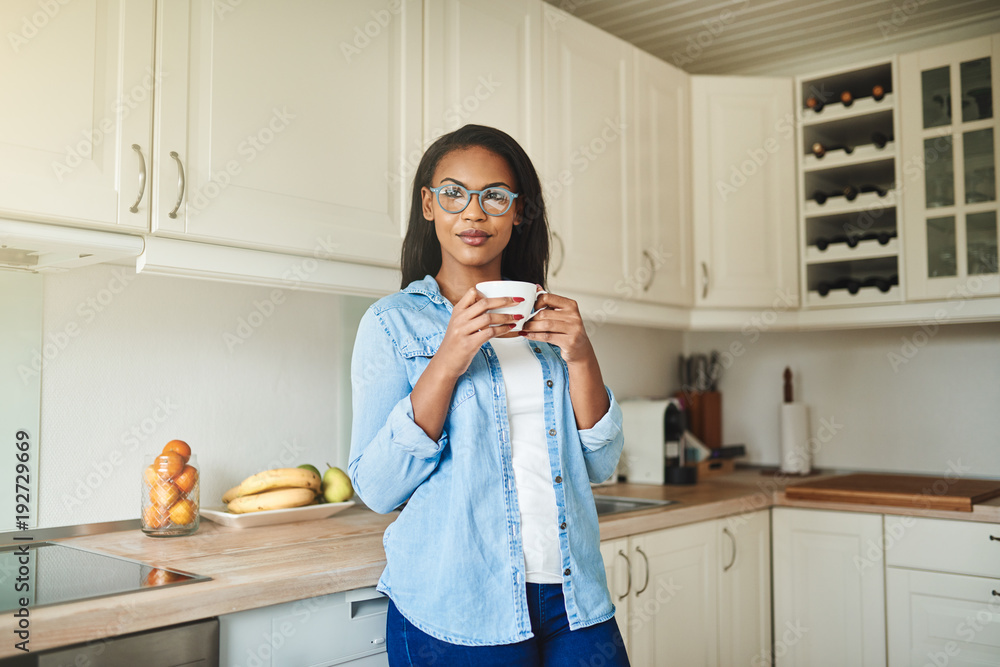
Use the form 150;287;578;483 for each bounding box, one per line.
350;125;628;667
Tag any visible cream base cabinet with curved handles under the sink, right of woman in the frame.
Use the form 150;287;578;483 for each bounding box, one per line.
601;510;771;667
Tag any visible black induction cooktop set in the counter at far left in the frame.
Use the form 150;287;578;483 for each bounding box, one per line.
0;542;210;613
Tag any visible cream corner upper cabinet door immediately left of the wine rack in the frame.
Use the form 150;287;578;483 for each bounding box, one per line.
691;76;798;308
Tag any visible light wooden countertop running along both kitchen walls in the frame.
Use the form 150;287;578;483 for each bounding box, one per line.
0;470;1000;657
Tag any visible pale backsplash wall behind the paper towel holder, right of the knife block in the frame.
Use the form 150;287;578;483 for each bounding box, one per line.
684;323;1000;477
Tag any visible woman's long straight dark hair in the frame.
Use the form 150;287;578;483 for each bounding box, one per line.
400;125;549;287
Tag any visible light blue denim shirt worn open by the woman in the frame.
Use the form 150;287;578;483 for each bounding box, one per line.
349;276;624;645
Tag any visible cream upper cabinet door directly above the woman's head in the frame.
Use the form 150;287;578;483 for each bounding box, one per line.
423;0;542;163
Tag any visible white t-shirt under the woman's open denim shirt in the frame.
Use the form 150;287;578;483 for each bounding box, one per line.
490;336;562;584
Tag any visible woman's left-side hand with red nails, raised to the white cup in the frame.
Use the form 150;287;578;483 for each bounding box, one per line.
434;287;524;379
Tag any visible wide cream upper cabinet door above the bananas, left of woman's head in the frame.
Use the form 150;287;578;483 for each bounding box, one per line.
153;0;422;266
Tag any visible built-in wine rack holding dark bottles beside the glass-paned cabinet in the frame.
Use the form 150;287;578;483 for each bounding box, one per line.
796;59;903;308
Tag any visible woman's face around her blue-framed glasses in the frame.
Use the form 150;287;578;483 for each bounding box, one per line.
421;146;519;279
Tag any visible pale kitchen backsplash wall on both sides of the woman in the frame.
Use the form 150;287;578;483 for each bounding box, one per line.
27;266;1000;527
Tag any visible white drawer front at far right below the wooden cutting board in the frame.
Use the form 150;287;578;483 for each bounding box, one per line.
885;515;1000;578
